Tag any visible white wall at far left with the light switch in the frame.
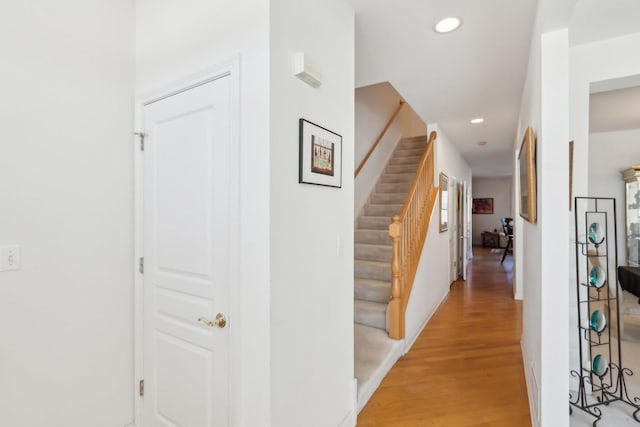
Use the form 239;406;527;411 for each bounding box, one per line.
0;0;135;427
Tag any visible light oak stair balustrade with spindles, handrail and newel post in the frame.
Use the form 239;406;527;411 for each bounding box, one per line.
388;132;438;339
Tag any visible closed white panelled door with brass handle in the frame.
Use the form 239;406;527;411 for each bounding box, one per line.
142;76;232;427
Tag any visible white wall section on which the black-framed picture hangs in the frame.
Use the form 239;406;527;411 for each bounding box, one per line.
269;0;355;427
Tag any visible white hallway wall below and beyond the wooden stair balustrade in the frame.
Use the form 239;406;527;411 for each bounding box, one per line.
405;124;472;351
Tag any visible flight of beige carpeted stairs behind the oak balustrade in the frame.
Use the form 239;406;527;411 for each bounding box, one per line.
354;135;428;332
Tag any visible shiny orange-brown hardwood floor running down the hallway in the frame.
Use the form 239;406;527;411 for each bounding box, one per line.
358;247;531;427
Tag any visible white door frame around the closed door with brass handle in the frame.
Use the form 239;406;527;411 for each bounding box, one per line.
132;54;241;427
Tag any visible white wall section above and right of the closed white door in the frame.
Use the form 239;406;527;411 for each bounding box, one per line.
136;0;272;427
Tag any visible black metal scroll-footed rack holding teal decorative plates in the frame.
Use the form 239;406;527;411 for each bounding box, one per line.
569;197;640;427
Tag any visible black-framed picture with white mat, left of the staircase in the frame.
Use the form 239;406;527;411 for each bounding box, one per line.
298;119;342;188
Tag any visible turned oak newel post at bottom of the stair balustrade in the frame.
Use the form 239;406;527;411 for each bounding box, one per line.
388;215;404;340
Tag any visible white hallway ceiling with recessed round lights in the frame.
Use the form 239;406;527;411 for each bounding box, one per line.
348;0;537;176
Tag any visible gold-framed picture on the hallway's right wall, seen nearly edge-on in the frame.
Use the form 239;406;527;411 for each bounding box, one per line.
518;127;537;224
